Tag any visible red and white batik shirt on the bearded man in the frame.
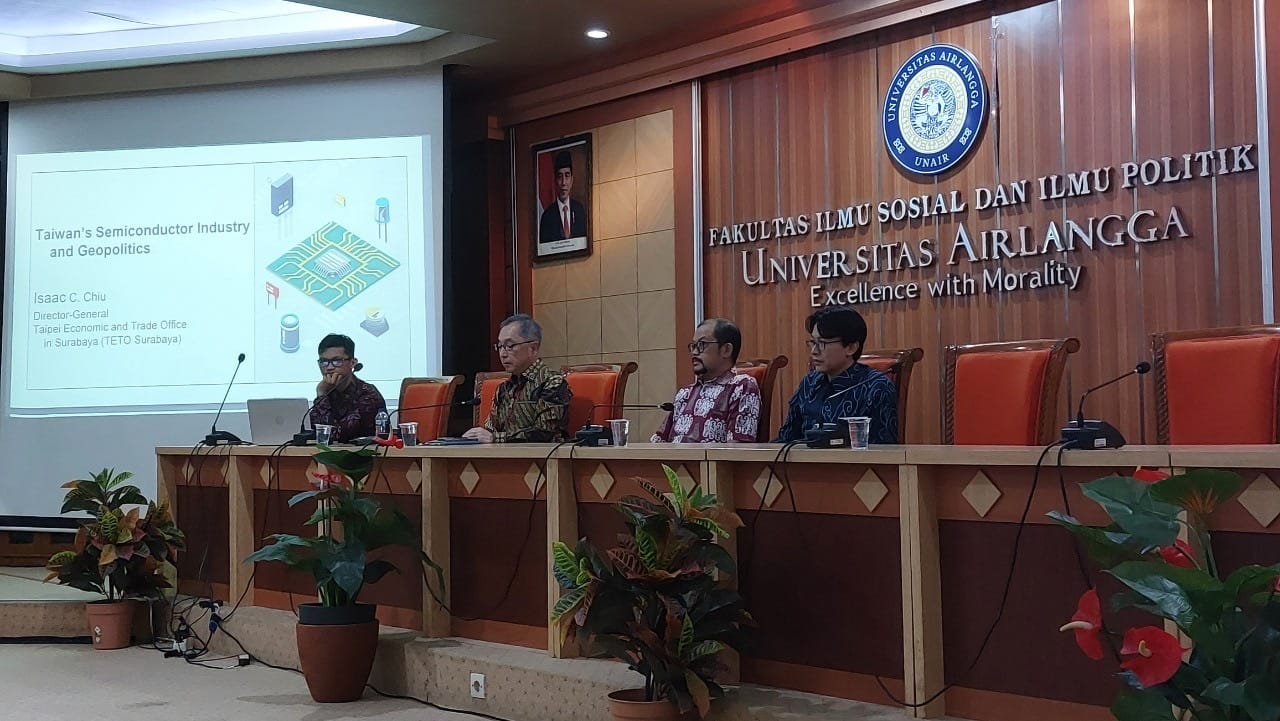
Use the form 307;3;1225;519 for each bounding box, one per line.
649;369;760;443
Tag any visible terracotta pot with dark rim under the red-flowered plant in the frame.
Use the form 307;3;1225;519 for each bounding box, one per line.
296;611;378;703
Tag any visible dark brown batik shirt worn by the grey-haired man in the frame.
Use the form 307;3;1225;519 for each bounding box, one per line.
484;359;573;443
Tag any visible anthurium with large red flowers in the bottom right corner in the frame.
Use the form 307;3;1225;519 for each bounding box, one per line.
1050;470;1280;721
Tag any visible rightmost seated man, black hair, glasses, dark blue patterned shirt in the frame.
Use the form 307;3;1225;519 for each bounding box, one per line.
774;307;897;443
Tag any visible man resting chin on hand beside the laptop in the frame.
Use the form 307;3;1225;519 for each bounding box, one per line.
311;333;387;442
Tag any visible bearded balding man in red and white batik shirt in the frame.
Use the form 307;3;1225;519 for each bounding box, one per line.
649;318;760;443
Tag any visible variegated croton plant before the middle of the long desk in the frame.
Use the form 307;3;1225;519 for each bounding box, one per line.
552;466;753;720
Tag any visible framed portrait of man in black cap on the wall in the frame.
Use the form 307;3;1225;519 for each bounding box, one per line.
532;133;591;263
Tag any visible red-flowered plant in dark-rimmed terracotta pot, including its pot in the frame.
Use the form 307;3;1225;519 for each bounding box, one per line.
246;446;444;703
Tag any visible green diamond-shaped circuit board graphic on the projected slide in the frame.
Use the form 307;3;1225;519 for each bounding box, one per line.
266;223;399;310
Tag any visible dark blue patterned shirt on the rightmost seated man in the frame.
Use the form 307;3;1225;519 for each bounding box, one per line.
774;362;897;443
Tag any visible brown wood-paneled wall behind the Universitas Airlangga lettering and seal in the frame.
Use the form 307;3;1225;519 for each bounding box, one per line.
698;0;1274;443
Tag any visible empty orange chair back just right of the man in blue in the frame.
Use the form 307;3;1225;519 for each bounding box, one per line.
942;338;1080;446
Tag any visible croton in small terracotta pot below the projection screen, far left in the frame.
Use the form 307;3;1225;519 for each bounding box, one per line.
45;469;186;649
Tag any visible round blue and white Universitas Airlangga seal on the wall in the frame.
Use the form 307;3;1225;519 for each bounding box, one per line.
883;45;987;175
